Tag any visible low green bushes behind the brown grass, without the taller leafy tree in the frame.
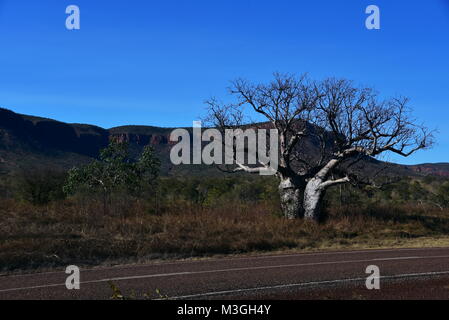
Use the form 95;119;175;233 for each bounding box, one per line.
2;170;449;213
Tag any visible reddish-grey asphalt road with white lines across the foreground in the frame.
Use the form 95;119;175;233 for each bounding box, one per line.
0;248;449;299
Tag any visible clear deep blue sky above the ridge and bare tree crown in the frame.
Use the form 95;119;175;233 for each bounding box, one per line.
0;0;449;163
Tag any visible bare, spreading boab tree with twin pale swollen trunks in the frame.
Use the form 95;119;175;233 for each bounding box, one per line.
206;74;433;221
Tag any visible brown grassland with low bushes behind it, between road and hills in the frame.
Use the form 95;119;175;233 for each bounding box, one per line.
0;156;449;271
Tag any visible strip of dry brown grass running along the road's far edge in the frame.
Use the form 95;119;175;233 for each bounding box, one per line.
0;199;449;271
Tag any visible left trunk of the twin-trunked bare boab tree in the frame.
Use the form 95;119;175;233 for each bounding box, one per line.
279;178;304;219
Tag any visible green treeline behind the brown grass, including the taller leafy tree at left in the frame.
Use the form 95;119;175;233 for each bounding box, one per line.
0;142;449;214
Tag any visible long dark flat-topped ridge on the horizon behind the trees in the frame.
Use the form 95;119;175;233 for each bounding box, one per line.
0;108;449;177
